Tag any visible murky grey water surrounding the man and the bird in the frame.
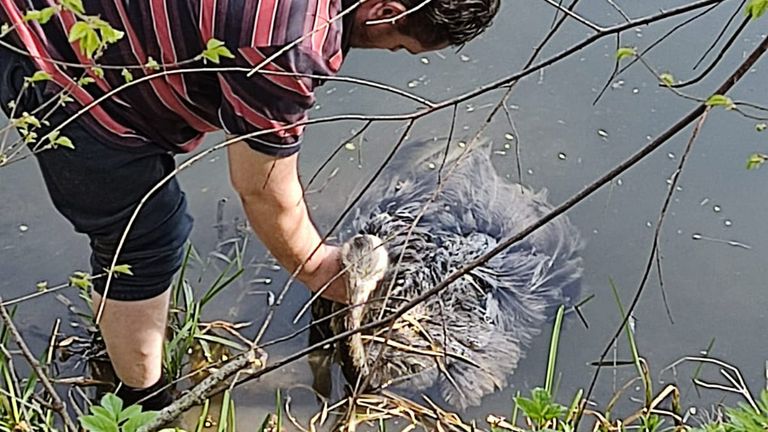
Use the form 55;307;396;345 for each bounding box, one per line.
0;0;768;425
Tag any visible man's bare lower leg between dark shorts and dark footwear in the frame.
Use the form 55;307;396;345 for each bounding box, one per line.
92;289;171;389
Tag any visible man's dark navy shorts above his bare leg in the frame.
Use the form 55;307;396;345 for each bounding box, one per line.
0;47;192;300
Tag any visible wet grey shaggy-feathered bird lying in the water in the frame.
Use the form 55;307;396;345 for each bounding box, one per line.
332;138;583;408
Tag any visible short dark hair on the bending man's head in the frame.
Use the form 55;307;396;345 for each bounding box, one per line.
400;0;499;47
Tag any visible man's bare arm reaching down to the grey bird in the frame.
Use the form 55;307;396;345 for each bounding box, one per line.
227;142;346;302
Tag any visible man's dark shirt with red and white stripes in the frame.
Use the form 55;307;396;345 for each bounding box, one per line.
0;0;352;156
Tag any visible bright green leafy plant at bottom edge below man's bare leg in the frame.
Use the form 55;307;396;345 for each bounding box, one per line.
80;393;158;432
